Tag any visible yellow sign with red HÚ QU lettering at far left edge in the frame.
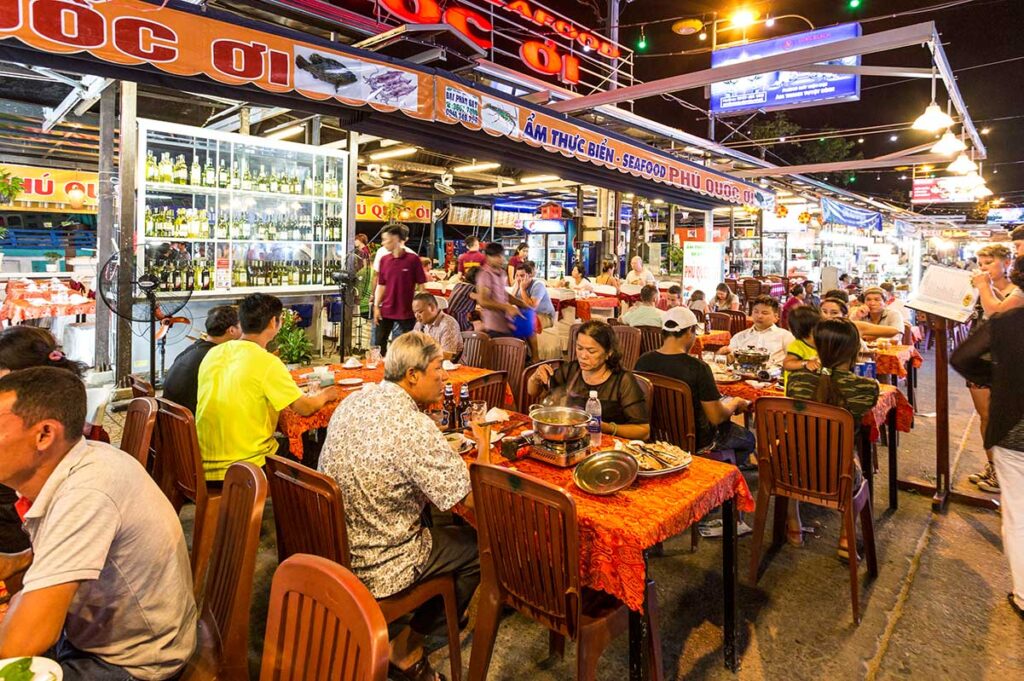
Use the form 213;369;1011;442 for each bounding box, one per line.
0;164;99;213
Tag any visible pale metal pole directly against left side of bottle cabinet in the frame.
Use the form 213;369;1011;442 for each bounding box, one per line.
115;81;138;385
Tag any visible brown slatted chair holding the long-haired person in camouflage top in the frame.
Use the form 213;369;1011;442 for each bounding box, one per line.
751;397;879;624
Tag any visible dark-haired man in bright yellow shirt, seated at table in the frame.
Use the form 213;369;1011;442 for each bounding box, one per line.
196;293;340;481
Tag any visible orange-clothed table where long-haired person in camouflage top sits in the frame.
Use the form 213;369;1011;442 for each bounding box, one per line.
718;381;913;509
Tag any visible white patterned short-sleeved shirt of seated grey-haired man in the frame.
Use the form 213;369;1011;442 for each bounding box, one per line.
319;381;470;598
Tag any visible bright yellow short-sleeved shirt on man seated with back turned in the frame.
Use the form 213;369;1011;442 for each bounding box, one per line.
196;337;299;480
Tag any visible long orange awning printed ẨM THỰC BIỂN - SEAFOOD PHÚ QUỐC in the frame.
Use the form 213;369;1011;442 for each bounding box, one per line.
0;0;773;210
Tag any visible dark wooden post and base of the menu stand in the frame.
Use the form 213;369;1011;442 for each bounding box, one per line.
899;313;998;513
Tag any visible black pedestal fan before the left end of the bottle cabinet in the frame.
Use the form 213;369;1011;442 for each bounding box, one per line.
96;245;195;386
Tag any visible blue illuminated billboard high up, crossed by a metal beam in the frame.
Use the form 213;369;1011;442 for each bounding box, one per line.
711;24;860;114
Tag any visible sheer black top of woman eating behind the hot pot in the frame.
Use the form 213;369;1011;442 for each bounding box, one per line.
548;361;650;424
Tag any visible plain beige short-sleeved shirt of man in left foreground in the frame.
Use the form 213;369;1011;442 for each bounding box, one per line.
25;439;197;679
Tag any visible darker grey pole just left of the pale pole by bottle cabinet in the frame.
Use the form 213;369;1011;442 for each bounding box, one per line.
92;84;118;372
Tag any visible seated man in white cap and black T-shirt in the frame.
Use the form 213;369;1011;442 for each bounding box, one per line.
636;307;754;461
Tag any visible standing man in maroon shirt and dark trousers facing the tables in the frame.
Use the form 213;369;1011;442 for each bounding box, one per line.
374;224;427;354
